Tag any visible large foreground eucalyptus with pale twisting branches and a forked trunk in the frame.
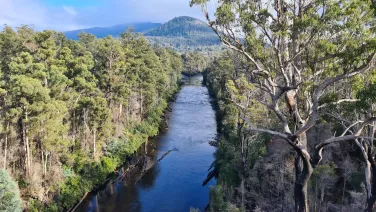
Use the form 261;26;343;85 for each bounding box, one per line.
191;0;376;211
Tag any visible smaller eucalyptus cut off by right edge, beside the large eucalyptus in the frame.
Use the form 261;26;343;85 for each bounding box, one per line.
326;80;376;211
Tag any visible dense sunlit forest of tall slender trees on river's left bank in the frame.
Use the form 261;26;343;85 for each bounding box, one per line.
0;26;182;211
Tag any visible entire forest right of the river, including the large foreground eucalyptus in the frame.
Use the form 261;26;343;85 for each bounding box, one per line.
191;0;376;212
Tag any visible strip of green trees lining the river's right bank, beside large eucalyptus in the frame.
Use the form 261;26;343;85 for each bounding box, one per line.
203;52;269;211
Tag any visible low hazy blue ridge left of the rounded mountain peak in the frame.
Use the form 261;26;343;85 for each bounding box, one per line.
64;22;162;40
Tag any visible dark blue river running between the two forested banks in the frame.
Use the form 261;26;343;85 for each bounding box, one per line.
78;76;216;212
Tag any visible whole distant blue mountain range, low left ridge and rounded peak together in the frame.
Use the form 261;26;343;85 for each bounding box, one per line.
64;16;220;51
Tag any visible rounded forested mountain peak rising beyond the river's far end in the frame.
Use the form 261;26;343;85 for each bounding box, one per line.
144;16;220;50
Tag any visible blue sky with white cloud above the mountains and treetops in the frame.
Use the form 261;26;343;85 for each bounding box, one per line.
0;0;214;31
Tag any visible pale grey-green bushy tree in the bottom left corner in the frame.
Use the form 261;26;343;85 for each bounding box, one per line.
0;169;22;212
